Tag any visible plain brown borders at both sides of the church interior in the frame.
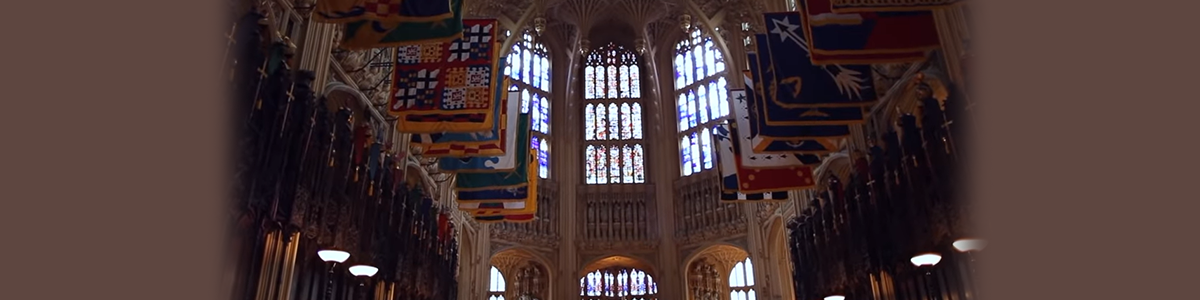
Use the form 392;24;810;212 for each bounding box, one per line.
0;0;1200;300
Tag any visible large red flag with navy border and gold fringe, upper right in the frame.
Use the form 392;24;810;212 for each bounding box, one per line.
796;0;938;65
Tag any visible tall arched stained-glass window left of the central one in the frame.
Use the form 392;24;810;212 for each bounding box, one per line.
504;32;550;179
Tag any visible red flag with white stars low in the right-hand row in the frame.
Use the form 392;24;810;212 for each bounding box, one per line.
713;124;820;202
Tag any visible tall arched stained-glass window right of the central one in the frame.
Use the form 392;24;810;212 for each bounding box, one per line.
674;30;730;176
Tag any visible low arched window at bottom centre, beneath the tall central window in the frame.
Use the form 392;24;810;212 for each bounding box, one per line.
580;268;659;300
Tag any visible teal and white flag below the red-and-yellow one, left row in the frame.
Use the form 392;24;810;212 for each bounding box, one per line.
438;103;529;173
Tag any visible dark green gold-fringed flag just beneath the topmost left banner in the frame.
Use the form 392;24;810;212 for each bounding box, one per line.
340;0;463;49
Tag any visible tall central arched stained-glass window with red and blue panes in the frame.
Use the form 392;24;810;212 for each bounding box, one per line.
583;43;646;185
